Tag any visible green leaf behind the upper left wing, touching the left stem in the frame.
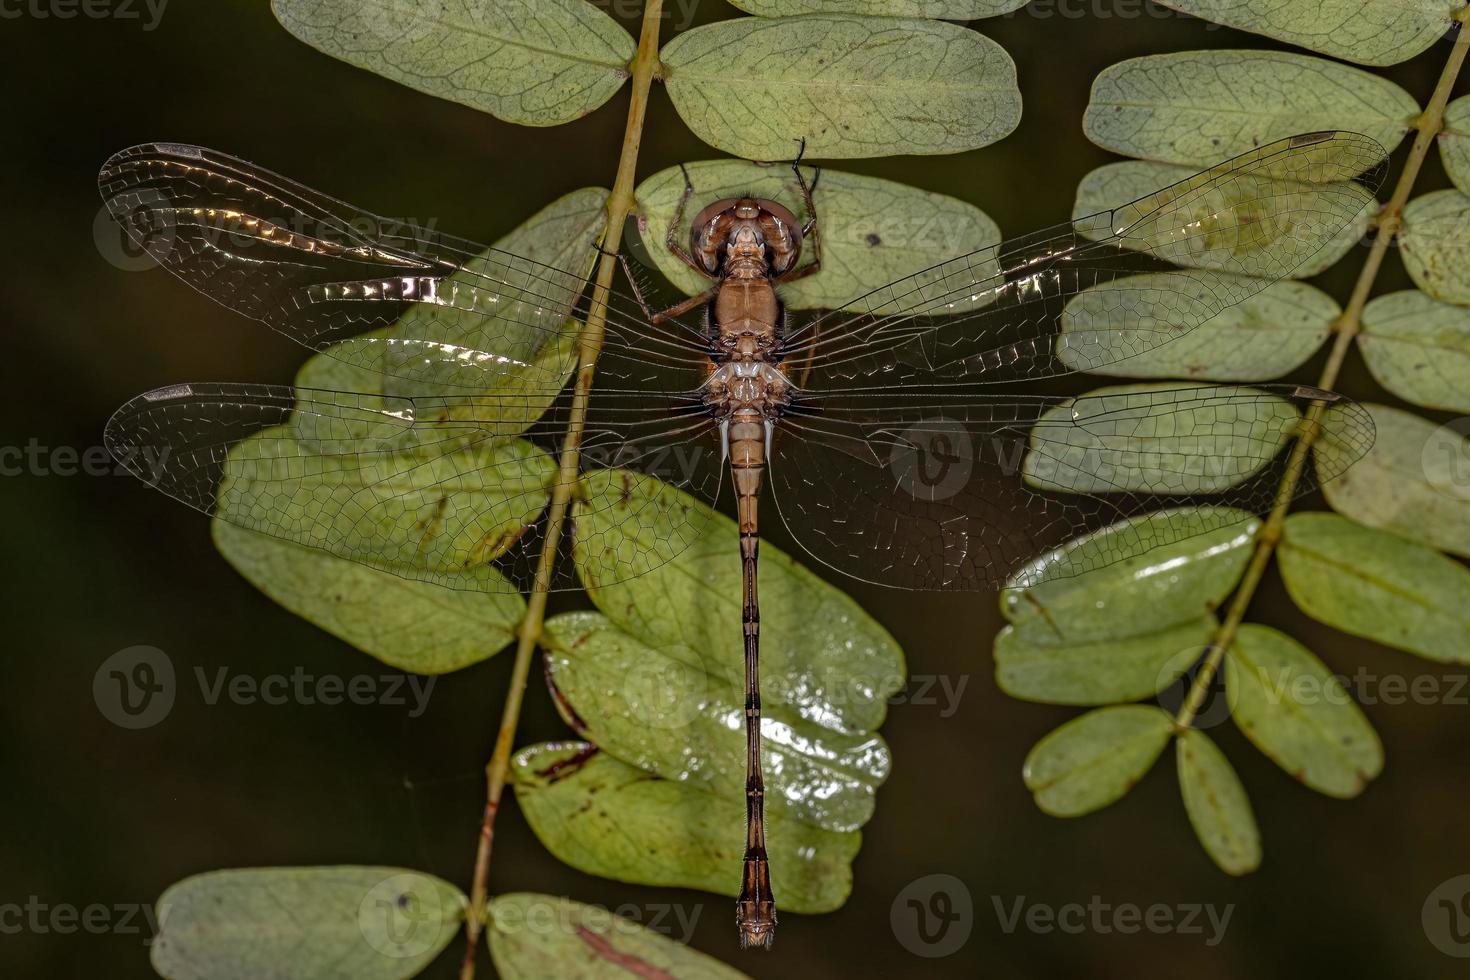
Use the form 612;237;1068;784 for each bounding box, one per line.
295;188;607;429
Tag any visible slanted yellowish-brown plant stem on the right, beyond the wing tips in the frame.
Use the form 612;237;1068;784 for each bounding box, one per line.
1175;6;1470;732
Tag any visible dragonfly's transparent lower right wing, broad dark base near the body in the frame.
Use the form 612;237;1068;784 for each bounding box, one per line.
767;385;1373;591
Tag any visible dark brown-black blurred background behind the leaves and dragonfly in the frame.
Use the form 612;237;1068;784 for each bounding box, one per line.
0;0;1470;980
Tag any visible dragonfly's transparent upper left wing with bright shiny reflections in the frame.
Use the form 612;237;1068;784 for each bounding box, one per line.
98;143;709;395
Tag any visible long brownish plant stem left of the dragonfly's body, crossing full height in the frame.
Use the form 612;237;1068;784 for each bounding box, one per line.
460;0;663;980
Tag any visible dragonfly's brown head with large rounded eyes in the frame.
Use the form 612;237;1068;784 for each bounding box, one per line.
689;197;801;278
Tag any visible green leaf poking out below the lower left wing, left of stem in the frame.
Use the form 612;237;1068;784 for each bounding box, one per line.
212;520;526;674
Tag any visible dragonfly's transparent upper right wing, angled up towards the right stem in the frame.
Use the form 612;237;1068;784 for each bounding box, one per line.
784;132;1386;384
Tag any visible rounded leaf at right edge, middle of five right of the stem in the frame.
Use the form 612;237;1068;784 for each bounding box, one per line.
1358;289;1470;411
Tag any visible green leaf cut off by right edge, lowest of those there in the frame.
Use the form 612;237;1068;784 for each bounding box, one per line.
1277;513;1470;664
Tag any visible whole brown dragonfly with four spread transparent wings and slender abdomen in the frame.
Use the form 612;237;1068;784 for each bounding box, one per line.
98;131;1386;948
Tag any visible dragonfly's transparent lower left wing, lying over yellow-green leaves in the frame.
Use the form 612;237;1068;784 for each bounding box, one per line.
106;383;719;592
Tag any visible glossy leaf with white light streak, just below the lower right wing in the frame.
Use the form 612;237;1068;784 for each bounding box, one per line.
1001;507;1261;646
